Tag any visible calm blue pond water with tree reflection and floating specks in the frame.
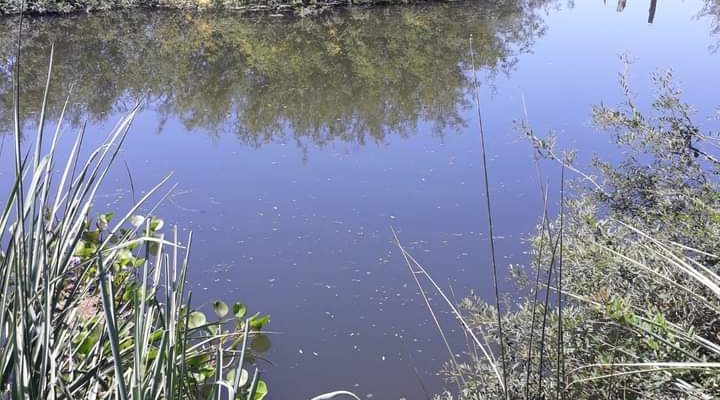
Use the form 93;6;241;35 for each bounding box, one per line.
0;0;720;399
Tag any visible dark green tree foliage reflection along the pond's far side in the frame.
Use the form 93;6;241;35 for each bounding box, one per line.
0;1;556;145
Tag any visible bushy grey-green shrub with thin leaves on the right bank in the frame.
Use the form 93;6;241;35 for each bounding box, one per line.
422;67;720;399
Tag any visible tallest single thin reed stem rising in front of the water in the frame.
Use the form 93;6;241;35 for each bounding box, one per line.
469;36;510;400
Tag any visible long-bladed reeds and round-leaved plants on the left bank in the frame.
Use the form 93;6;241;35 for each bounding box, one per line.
0;38;276;400
